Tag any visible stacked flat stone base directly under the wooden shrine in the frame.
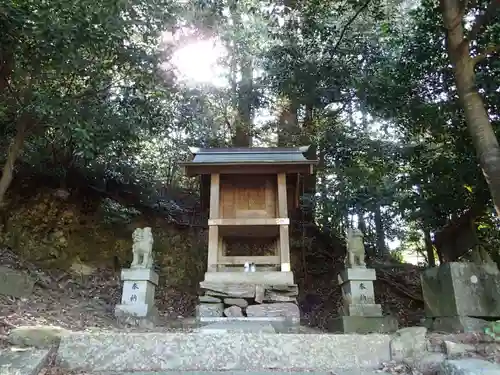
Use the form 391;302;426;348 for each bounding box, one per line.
196;281;300;323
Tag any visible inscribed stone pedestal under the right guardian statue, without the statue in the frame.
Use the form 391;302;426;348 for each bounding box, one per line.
332;268;398;333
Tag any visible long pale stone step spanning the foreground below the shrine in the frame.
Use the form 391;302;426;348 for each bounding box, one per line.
57;331;390;372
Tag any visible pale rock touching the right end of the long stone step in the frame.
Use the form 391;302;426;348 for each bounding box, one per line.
389;327;427;361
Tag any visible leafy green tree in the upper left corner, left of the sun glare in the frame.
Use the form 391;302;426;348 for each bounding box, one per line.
0;0;175;206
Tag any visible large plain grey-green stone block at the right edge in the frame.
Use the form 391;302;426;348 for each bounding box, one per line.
421;262;500;332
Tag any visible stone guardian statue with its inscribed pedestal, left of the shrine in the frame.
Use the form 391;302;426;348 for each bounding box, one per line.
115;227;158;325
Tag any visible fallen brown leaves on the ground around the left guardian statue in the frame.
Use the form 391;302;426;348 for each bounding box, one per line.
0;249;196;334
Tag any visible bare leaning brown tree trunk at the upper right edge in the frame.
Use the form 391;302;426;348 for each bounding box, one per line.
441;0;500;216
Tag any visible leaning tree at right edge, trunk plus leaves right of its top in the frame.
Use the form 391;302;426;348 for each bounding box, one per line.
441;0;500;216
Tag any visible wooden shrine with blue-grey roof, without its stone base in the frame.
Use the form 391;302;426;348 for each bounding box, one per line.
182;146;317;320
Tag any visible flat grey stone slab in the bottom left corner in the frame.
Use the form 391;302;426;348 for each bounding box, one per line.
0;349;51;375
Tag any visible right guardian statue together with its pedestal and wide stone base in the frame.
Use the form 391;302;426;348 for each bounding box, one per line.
330;229;398;333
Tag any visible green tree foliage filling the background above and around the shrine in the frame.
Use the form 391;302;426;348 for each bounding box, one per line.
0;0;500;268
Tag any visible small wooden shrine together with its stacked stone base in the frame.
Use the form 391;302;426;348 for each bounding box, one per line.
182;147;317;323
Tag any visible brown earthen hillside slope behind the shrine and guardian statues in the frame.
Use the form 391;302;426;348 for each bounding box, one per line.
0;181;423;329
